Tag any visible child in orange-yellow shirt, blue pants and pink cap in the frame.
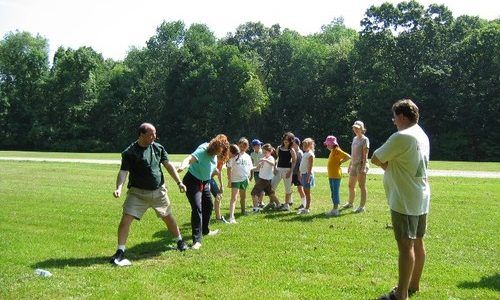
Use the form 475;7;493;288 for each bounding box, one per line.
323;135;351;217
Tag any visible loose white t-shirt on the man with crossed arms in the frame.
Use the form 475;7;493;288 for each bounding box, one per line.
373;124;430;216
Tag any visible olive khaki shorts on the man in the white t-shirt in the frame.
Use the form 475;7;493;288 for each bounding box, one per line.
391;210;427;240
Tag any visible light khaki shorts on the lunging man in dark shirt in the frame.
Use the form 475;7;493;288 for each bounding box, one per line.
123;186;172;220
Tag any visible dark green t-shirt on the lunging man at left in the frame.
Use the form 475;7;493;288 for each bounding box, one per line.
120;141;168;190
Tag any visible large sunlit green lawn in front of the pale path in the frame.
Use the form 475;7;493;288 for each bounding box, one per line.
0;159;500;299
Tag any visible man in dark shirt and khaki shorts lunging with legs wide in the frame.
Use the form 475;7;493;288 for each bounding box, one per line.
111;123;187;264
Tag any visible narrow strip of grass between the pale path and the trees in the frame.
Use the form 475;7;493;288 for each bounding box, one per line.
0;151;500;172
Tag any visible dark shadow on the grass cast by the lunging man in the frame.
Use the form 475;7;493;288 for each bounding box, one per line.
31;229;186;269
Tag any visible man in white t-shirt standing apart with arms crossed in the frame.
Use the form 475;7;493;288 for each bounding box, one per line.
372;99;430;299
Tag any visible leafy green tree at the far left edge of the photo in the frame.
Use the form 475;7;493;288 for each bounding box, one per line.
0;31;49;149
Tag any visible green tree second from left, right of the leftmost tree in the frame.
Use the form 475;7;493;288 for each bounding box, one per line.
40;47;106;151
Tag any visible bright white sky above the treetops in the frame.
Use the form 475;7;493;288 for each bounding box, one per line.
0;0;500;60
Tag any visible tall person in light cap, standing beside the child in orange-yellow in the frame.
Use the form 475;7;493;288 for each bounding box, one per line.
348;121;370;213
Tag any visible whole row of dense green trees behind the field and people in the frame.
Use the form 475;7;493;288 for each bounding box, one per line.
0;1;500;161
